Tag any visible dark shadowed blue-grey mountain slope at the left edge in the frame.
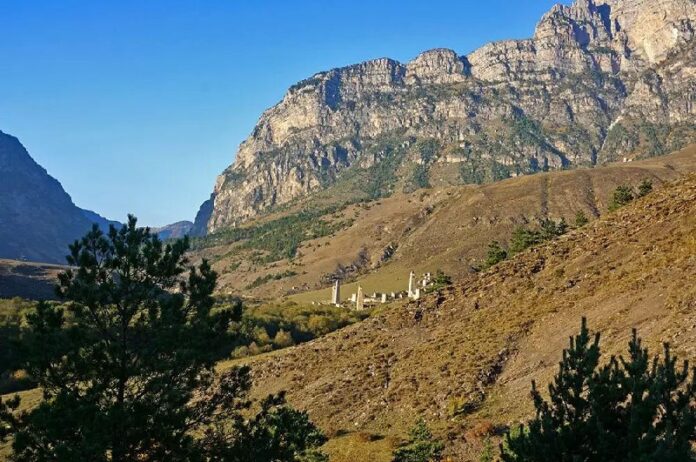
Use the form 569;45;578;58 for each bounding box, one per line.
0;132;116;263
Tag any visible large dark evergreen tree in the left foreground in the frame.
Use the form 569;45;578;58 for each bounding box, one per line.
0;216;323;462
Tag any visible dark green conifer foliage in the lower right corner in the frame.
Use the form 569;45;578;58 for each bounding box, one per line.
501;319;696;462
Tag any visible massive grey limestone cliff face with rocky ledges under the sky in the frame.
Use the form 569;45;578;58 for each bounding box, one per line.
195;0;696;232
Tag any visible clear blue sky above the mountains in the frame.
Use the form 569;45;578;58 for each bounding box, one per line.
0;0;555;226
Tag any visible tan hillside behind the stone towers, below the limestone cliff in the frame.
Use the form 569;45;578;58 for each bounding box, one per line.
194;145;696;302
